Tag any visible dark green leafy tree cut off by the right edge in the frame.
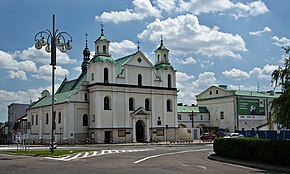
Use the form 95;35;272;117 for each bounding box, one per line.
271;47;290;129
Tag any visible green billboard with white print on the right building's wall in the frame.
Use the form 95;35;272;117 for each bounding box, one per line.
238;98;265;120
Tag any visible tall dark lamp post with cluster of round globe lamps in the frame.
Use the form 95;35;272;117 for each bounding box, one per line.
34;15;72;153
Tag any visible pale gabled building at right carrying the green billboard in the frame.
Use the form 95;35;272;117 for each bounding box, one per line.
196;85;279;132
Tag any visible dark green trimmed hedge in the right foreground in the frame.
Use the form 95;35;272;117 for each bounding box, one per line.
213;138;290;166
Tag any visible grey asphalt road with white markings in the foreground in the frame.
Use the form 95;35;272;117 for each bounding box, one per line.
0;144;282;174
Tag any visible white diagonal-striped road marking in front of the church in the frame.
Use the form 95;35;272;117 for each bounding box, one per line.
45;149;154;161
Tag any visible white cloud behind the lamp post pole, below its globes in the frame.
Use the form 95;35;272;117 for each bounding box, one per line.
32;65;69;81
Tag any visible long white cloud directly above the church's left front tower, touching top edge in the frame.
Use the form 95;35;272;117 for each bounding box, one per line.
95;0;161;23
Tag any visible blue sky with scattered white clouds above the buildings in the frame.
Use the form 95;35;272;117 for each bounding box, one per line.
0;0;290;122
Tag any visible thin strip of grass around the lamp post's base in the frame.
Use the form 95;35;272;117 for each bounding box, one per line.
0;149;95;157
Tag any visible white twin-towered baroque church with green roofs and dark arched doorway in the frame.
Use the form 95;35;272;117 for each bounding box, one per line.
28;28;178;144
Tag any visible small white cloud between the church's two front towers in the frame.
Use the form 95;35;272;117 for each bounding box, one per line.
110;39;137;57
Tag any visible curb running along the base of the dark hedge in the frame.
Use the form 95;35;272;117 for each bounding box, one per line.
207;153;290;173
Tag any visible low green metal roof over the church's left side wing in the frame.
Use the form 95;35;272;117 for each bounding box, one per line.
30;90;78;109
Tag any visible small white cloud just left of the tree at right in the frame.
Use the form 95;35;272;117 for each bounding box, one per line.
249;64;278;79
